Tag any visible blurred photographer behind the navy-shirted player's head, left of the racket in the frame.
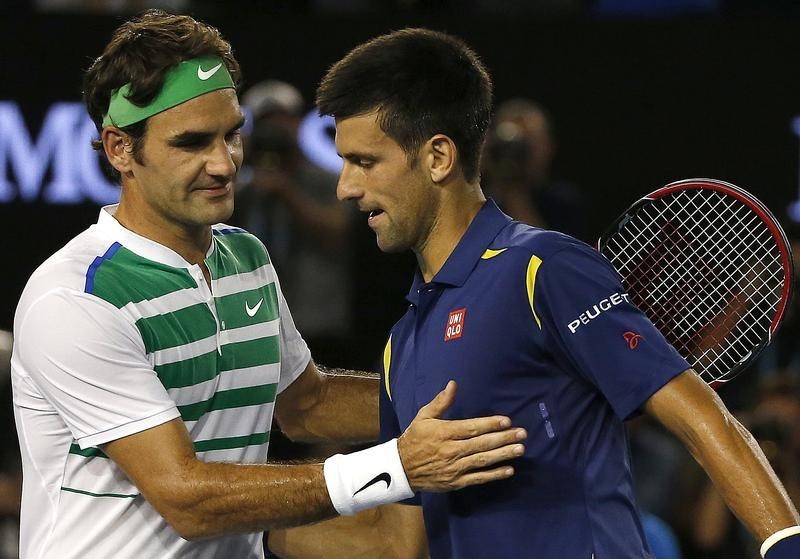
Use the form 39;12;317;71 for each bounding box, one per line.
483;99;596;241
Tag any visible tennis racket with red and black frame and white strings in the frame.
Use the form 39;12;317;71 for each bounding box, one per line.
597;179;793;387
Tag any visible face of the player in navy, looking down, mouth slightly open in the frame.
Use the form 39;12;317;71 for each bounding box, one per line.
336;112;438;252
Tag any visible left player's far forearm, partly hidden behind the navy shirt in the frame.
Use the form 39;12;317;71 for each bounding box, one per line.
281;365;380;443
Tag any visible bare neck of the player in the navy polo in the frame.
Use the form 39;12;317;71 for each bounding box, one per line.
414;184;486;282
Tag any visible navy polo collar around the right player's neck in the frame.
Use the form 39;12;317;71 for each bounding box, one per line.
406;198;511;304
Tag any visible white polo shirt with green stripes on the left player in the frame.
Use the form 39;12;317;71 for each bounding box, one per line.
12;207;310;558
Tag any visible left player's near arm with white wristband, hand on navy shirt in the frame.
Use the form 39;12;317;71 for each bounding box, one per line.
101;394;525;539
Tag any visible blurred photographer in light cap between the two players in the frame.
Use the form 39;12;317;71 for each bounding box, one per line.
233;80;352;366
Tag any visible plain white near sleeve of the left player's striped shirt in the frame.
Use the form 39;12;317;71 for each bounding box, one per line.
15;289;180;448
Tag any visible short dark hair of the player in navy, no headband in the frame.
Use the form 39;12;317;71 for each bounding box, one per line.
317;28;492;181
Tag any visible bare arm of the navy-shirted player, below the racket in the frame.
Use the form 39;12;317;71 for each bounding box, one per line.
645;370;800;559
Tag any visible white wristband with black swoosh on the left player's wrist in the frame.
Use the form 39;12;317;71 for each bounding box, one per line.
323;439;414;516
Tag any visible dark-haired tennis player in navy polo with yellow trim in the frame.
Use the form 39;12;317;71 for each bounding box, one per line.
317;29;800;559
